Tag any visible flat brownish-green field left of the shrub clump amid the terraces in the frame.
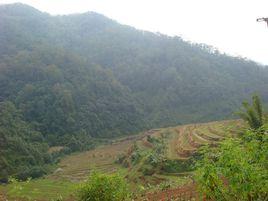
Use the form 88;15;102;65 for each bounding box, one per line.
49;140;132;182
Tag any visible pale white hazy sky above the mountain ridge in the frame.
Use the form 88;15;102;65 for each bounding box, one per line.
0;0;268;65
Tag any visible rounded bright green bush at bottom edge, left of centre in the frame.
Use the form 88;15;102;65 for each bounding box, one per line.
77;172;130;201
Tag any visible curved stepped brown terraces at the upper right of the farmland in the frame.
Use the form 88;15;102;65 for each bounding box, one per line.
165;120;243;159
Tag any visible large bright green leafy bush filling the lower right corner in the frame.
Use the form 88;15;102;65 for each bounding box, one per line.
196;128;268;201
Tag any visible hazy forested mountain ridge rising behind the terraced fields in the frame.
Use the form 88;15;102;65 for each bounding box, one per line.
0;4;268;181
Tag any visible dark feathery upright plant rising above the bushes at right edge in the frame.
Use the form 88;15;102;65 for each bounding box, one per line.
238;95;264;129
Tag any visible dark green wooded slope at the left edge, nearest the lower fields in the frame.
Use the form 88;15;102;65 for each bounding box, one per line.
0;101;52;182
